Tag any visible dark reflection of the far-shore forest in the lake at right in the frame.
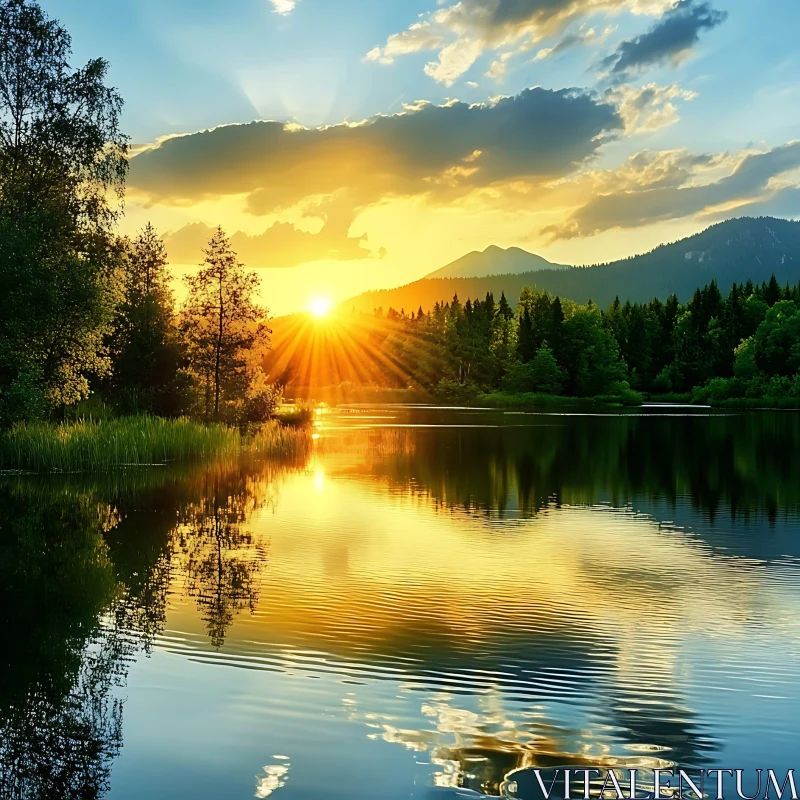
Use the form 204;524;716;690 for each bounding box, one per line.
369;413;800;520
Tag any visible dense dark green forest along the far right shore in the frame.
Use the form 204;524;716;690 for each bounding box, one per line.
375;275;800;407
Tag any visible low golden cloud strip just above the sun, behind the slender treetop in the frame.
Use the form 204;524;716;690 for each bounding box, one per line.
164;216;381;267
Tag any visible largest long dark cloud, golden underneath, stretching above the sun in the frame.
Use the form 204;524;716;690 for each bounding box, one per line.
129;88;622;214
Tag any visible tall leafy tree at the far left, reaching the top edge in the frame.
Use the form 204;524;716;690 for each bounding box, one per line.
0;0;127;424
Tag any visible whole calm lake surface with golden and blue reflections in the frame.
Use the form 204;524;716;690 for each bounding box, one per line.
0;407;800;800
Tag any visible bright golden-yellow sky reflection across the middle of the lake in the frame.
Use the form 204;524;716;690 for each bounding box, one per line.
166;454;800;672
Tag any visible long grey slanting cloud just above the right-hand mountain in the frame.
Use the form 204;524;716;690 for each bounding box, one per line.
542;141;800;239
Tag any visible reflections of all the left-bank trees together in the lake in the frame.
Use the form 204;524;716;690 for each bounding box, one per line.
0;465;292;800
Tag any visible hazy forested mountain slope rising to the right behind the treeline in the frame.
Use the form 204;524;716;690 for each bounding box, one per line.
342;217;800;312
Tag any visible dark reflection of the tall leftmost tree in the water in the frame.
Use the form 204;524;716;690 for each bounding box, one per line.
0;487;129;800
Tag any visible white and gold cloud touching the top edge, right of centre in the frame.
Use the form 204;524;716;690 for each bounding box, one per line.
367;0;674;85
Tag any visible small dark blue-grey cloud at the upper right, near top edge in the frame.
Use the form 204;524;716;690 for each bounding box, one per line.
602;0;728;80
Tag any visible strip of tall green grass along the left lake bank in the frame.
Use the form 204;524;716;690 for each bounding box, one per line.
0;417;307;473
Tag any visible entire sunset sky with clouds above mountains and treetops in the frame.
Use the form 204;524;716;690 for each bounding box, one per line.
42;0;800;314
